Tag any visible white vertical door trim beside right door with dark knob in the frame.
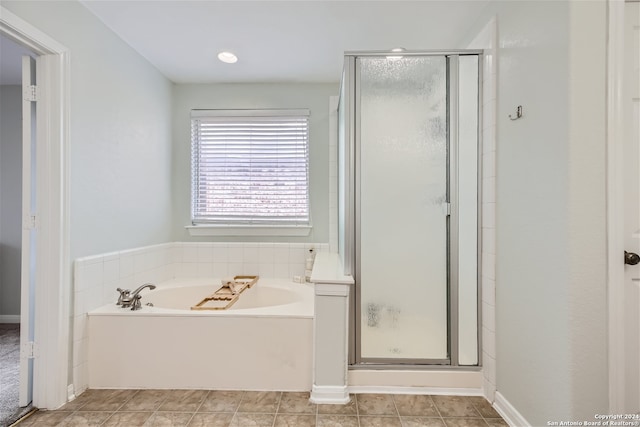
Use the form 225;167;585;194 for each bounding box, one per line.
607;0;625;414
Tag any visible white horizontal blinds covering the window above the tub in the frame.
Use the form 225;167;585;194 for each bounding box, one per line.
191;110;309;225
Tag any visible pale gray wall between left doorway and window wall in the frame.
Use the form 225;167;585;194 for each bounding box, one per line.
2;1;171;259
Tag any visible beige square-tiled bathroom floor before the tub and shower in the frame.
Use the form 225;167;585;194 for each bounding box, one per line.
15;390;507;427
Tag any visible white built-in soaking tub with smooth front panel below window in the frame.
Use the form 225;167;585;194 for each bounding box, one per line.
88;279;313;391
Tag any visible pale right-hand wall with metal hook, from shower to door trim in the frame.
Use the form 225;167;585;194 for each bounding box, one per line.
461;1;608;425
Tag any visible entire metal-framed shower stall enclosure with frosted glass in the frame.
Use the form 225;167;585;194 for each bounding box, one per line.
338;51;482;367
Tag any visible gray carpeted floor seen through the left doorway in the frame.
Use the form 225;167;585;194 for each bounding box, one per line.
0;323;22;426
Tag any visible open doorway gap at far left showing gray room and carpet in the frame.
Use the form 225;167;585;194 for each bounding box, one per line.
0;32;34;425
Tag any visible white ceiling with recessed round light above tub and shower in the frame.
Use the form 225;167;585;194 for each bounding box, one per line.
82;0;488;83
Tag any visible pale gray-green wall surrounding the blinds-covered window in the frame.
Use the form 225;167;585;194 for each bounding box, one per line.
172;83;339;242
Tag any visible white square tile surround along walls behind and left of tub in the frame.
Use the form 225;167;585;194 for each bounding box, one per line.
73;242;329;394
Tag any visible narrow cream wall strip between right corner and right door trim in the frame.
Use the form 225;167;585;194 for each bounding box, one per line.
568;1;609;420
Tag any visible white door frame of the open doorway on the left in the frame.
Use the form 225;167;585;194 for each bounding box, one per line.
0;6;71;409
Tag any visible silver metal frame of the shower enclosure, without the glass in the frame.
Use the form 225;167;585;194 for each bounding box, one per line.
339;50;484;370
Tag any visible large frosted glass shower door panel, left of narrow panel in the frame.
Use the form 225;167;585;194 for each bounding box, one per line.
356;56;448;360
